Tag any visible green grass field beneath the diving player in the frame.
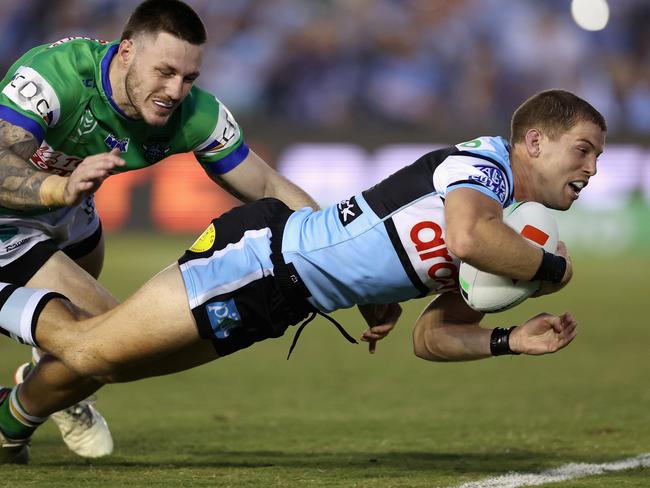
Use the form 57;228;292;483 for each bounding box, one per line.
0;235;650;488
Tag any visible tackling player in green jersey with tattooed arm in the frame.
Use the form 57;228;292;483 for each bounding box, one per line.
0;0;316;464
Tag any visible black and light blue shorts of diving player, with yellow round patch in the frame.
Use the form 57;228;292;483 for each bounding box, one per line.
178;198;314;356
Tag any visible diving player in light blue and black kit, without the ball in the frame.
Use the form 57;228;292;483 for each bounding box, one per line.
0;90;606;457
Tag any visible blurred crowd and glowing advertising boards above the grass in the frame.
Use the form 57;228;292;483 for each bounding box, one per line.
0;0;650;244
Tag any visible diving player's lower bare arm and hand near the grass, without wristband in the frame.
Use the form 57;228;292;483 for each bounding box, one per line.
413;293;577;361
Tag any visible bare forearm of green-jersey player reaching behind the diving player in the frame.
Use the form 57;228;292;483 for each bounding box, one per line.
208;150;318;210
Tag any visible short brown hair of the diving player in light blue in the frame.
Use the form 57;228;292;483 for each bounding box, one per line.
510;90;607;144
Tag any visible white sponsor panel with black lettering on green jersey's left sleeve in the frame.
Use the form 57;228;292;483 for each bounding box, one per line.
2;66;61;126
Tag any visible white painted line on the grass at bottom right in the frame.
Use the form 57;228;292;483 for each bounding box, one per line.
450;452;650;488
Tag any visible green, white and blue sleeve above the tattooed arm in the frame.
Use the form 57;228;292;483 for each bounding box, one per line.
0;47;80;142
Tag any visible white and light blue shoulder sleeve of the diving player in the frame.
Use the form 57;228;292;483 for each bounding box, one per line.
433;153;511;205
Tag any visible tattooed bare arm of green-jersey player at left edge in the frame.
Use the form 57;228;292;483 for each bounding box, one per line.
0;119;50;209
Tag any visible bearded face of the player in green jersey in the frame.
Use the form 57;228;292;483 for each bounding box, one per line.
125;32;203;126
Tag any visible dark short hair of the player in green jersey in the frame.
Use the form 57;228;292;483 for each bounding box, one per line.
120;0;207;46
